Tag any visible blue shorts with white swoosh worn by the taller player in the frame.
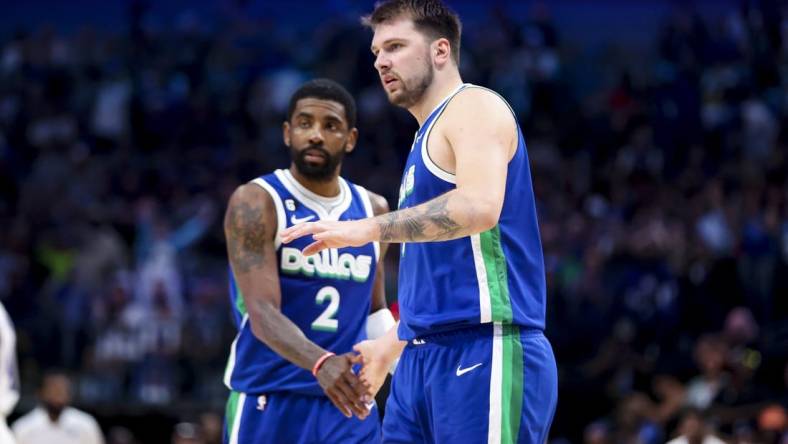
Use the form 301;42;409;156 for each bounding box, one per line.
383;323;558;444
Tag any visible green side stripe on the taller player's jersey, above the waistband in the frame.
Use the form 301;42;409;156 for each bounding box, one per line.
479;225;512;324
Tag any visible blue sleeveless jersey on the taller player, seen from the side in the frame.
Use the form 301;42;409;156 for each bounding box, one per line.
398;84;545;340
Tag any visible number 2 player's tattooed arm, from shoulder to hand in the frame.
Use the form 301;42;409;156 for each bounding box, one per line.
224;184;368;417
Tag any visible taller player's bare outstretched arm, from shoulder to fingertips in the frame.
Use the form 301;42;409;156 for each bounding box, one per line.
282;88;517;254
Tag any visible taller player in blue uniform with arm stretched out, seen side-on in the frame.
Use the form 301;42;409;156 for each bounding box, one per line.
283;0;557;444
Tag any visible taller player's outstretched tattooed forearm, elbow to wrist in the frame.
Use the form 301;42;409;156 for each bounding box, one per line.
372;189;500;242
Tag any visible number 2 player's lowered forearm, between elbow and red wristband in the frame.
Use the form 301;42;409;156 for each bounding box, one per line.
249;301;326;371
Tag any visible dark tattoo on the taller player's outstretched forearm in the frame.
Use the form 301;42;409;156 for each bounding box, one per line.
378;196;462;242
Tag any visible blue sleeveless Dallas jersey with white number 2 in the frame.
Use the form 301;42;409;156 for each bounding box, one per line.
224;170;380;395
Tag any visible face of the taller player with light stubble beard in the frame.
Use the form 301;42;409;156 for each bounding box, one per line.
372;17;434;108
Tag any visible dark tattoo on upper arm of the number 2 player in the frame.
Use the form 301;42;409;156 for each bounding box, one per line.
227;202;266;273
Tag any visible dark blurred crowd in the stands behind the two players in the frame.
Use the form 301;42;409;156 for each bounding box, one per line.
0;1;788;444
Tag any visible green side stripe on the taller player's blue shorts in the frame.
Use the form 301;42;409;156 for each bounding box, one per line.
500;324;523;443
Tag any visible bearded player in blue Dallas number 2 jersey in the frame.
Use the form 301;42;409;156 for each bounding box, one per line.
224;79;394;444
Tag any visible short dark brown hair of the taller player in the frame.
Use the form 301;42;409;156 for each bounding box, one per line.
361;0;462;65
